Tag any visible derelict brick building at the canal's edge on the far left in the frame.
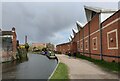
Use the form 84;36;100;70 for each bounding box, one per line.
0;27;17;62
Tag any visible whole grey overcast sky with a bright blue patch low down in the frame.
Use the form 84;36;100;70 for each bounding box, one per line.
2;2;118;44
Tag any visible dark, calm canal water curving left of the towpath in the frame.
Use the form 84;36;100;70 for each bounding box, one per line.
2;53;57;79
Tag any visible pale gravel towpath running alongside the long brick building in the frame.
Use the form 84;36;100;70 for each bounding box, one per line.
56;54;118;79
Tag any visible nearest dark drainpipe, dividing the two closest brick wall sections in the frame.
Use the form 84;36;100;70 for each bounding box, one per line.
99;13;103;60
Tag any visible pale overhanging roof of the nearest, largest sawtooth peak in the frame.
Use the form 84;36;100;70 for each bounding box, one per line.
84;6;117;13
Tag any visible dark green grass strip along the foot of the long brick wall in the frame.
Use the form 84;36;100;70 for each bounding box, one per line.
77;54;120;73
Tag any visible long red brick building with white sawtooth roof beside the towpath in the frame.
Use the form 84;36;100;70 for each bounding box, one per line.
57;6;120;62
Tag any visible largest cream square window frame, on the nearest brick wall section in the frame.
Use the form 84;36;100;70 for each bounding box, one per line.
107;29;118;49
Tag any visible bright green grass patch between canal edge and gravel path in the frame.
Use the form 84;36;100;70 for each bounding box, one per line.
49;62;69;81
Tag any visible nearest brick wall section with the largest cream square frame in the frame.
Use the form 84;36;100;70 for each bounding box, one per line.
102;11;120;62
